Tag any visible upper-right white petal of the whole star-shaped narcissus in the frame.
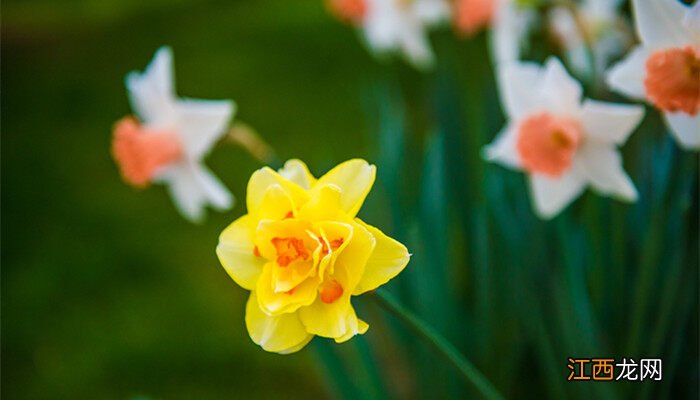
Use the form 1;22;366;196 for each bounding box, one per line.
581;99;644;144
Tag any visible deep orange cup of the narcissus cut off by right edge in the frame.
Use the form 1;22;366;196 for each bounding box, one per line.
644;46;700;115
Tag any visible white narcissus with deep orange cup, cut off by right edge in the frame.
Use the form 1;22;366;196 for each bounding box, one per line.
607;0;700;150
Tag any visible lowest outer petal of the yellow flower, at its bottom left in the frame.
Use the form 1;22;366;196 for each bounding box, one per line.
245;292;313;354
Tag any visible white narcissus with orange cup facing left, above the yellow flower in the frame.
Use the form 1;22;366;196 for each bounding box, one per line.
112;47;236;221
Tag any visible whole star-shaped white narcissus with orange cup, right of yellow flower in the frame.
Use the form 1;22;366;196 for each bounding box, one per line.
484;58;644;218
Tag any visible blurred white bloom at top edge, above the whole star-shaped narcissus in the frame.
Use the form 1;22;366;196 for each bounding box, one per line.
549;0;631;79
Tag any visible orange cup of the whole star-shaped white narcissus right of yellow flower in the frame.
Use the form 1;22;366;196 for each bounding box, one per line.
516;113;583;177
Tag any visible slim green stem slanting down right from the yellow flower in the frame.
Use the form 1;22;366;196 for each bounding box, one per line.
373;289;503;400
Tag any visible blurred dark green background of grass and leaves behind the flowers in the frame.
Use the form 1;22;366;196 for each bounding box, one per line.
1;0;698;399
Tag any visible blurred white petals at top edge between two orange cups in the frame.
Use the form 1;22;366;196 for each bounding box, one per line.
360;0;450;68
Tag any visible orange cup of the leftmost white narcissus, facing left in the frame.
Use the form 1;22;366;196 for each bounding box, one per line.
112;117;183;187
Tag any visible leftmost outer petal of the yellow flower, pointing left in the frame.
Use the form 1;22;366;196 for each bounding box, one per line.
216;215;265;290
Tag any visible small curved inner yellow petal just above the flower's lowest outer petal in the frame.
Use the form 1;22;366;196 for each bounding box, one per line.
256;262;318;315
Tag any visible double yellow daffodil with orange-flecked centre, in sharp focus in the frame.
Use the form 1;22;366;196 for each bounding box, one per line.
216;160;410;354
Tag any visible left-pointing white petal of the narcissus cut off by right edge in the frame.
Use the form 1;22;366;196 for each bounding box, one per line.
606;46;651;100
